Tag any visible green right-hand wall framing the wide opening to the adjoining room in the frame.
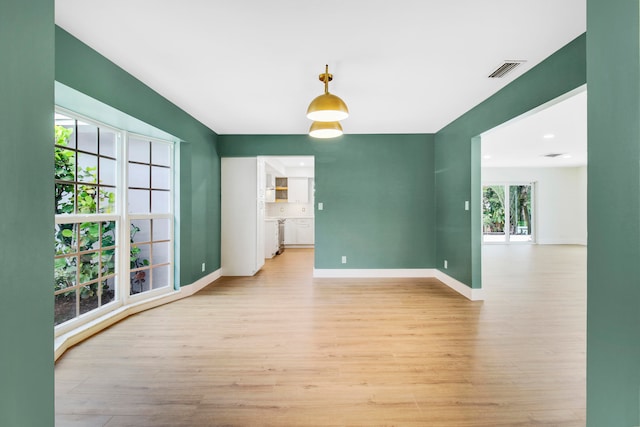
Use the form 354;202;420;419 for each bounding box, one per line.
435;34;586;288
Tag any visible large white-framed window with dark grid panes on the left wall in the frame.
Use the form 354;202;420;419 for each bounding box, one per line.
54;112;173;326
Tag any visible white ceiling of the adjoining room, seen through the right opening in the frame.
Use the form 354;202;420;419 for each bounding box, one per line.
481;87;587;167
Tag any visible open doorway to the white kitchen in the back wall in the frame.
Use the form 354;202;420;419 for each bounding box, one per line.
220;156;315;276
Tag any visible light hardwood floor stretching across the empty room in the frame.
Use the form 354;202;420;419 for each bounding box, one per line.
55;245;586;427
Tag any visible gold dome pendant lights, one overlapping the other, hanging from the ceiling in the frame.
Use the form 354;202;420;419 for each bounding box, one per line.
307;65;349;138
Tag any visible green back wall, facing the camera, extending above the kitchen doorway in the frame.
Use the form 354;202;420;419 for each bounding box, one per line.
218;135;435;269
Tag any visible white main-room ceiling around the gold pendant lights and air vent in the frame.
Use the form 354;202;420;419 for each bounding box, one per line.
55;0;586;134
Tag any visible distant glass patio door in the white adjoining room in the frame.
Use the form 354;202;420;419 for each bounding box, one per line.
482;183;534;243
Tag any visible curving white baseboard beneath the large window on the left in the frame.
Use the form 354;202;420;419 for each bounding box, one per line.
54;270;220;361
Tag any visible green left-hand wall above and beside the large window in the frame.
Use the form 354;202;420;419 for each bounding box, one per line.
55;27;220;285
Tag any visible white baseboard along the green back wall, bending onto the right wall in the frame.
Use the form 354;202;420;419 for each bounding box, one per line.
313;268;484;301
